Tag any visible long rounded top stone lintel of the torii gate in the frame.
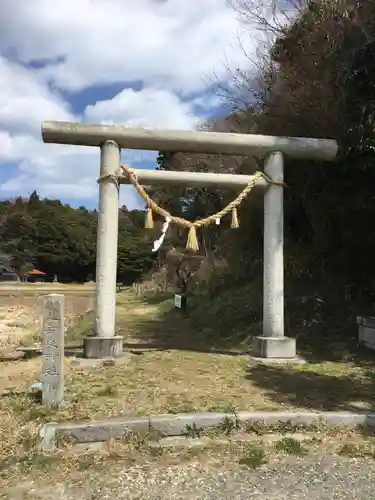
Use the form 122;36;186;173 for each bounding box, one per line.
42;121;338;161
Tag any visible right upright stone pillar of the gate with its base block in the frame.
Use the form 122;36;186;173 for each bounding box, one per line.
254;152;296;358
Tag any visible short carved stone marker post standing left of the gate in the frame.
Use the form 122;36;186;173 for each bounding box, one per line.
42;293;65;406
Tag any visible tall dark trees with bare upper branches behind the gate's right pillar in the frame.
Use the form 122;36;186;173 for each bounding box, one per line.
156;0;375;300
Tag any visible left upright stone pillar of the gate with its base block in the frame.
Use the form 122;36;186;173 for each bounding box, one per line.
84;140;122;359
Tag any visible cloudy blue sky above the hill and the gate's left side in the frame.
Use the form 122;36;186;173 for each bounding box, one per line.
0;0;264;208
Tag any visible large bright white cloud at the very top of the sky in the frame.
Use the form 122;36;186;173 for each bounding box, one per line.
0;0;256;92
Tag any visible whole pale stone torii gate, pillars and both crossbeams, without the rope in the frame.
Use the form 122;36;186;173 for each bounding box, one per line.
42;122;338;359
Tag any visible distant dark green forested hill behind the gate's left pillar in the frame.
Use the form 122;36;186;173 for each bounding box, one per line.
0;192;154;283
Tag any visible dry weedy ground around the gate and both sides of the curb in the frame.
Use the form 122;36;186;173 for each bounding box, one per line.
0;289;375;494
